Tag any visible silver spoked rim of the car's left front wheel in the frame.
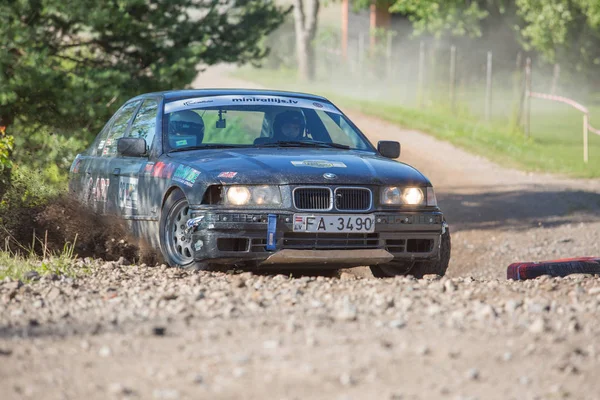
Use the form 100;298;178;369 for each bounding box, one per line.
165;199;194;265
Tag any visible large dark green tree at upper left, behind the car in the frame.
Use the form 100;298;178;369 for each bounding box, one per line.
0;0;286;196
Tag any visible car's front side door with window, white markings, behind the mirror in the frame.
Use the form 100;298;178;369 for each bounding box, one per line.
110;98;159;221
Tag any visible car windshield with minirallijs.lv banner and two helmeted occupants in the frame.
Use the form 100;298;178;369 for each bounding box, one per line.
165;95;373;152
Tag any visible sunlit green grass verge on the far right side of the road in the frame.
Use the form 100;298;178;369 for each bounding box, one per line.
236;68;600;178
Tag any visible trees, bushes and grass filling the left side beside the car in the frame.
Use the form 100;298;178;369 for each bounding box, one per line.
0;0;289;278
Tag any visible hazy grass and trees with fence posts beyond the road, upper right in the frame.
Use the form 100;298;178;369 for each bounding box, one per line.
236;0;600;178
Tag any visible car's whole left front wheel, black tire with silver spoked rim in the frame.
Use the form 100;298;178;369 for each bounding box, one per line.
159;190;208;270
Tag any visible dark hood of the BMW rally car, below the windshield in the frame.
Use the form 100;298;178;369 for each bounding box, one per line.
164;148;430;186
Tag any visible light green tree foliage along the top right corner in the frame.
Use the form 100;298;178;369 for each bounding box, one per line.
376;0;600;86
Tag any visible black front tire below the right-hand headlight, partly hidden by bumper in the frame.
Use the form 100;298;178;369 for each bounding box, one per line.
370;220;452;279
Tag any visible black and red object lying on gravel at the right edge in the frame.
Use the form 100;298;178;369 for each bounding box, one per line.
506;257;600;281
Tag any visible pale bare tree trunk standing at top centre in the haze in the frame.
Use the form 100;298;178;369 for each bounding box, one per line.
294;0;319;80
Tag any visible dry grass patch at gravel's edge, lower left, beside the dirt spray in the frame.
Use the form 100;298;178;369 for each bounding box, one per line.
0;234;88;282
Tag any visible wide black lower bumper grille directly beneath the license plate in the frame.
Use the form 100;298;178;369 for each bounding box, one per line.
283;232;379;250
